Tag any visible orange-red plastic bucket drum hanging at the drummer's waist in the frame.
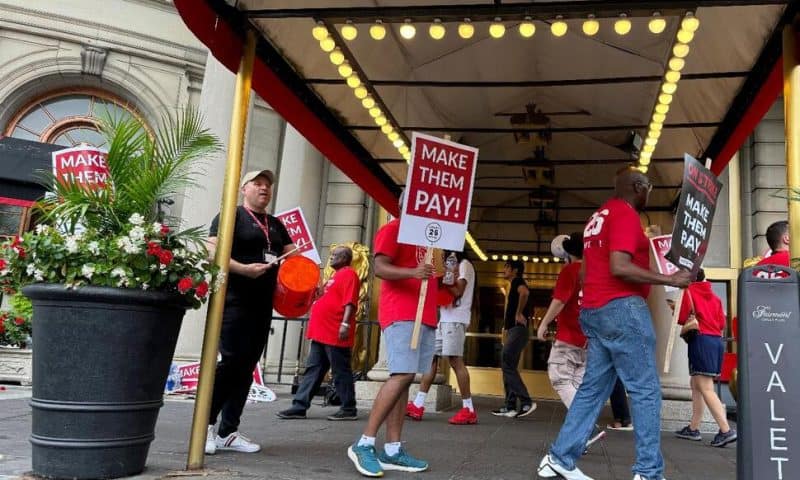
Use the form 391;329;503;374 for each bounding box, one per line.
272;255;319;317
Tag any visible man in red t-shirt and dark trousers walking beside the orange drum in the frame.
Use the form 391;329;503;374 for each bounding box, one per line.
277;246;361;420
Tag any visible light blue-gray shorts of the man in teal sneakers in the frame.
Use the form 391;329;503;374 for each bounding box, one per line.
383;321;436;375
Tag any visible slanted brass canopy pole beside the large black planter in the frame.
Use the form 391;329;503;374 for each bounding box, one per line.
186;30;256;470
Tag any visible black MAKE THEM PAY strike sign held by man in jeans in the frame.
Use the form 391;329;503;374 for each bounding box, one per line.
666;154;722;273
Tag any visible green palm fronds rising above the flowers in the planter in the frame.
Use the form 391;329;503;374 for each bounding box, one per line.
42;109;220;234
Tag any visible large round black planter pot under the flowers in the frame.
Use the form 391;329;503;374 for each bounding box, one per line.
23;284;186;478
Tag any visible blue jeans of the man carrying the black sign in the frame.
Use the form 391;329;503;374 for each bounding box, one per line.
550;296;664;479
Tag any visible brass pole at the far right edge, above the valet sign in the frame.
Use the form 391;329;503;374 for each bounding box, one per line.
783;17;800;258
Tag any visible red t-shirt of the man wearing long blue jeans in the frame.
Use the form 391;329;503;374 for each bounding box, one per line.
582;198;650;308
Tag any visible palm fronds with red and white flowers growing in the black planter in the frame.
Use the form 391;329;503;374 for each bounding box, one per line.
0;110;220;307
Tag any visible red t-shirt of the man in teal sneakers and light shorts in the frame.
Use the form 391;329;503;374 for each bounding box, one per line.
375;219;437;329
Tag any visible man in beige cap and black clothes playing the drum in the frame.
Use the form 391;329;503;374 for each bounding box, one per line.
205;170;295;455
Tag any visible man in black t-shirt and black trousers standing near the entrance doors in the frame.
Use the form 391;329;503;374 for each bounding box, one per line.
492;260;536;418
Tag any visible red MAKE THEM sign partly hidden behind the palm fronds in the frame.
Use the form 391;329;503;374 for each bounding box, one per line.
53;145;109;190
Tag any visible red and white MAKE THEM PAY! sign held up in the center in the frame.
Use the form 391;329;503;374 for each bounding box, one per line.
398;132;478;251
